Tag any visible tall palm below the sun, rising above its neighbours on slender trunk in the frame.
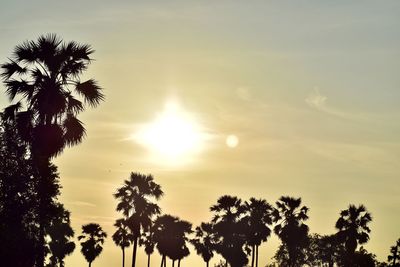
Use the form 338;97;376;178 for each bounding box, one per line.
114;172;163;267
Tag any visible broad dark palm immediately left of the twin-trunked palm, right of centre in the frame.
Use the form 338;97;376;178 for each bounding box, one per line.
210;195;248;267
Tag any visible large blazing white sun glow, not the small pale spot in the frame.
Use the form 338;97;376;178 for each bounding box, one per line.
134;102;204;163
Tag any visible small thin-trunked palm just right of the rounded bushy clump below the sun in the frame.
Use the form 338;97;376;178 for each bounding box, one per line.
190;223;214;267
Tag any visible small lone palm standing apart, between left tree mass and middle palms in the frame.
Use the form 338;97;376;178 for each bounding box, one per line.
78;223;107;267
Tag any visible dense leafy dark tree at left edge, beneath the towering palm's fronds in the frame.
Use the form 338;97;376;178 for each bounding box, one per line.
0;115;38;267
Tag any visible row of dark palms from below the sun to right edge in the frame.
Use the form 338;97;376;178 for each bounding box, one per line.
107;173;400;267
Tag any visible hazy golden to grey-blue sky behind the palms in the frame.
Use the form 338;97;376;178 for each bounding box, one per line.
0;0;400;267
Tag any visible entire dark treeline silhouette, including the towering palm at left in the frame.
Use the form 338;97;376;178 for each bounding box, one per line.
0;34;400;267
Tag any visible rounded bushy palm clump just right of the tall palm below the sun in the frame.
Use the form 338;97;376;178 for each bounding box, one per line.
154;215;192;266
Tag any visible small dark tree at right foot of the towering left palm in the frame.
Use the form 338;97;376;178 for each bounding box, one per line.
47;204;75;267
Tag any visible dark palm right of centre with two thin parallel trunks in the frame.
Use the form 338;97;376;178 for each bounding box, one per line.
244;198;275;267
